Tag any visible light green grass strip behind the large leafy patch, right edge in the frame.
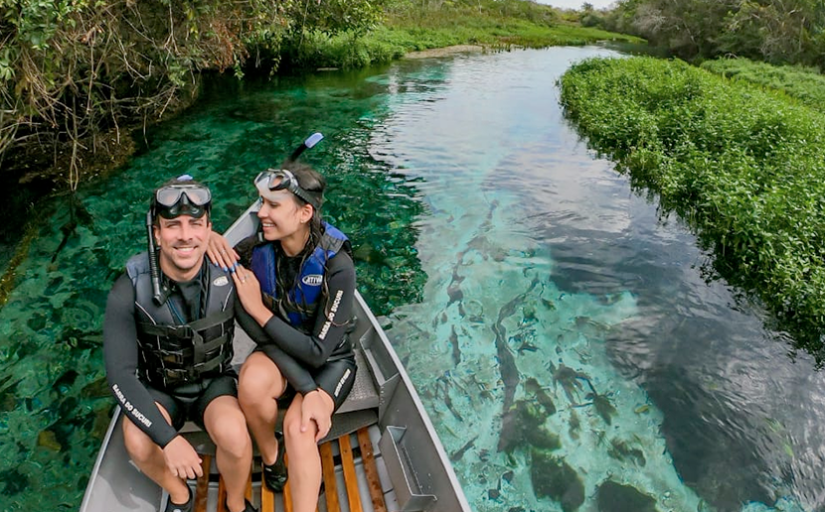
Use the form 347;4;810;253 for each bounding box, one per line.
701;58;825;112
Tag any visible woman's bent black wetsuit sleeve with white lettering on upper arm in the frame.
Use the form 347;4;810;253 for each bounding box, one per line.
264;252;355;368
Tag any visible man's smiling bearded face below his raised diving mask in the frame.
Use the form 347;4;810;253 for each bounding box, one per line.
155;215;212;281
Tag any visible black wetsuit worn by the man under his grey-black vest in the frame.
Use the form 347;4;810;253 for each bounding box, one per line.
103;263;237;448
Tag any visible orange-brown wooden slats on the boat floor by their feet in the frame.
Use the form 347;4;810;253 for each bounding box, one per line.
190;424;396;512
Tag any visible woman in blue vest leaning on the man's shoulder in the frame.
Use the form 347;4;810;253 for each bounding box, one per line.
209;161;356;512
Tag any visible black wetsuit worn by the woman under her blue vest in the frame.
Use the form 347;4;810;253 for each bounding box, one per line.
235;237;356;409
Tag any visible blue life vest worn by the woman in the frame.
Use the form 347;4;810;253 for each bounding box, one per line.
251;222;351;332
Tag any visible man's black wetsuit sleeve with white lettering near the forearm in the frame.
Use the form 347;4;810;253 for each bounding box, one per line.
103;274;177;448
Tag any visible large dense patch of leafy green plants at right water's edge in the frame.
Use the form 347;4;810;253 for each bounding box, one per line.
560;57;825;364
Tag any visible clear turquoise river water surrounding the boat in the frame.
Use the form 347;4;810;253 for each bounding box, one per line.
0;48;825;512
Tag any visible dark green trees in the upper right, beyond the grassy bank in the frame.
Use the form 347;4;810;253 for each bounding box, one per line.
581;0;825;69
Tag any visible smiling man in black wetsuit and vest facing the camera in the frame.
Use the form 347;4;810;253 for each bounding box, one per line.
103;175;254;512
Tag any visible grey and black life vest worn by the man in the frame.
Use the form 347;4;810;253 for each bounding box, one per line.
126;252;235;388
